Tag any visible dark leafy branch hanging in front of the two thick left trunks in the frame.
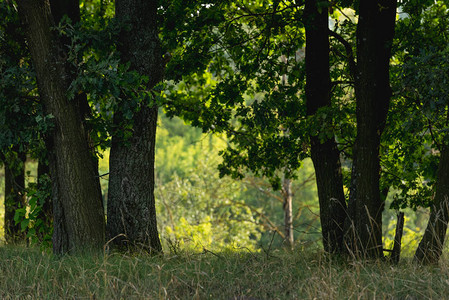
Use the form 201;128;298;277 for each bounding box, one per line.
54;14;158;150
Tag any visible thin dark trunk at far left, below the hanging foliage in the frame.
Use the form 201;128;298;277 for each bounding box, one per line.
4;152;26;244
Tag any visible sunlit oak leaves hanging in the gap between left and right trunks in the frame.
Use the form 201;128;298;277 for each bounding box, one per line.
163;1;312;188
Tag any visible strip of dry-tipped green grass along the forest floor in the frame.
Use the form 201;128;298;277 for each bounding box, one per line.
0;247;449;300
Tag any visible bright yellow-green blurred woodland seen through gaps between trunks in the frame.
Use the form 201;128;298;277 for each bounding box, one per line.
0;114;428;255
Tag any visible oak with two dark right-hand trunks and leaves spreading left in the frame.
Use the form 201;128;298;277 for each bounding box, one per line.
162;1;396;257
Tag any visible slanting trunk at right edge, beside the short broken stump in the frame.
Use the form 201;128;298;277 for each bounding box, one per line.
415;141;449;264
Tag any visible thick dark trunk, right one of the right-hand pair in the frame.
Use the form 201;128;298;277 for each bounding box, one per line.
346;0;397;258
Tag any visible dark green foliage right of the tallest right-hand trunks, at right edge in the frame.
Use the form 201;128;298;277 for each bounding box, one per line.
382;1;449;210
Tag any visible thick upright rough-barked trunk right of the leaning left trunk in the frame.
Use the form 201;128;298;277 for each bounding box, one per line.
107;0;164;253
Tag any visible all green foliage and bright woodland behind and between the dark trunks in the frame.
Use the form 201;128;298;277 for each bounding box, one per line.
0;0;449;262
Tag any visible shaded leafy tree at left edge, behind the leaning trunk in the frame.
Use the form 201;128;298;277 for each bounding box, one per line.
0;1;51;244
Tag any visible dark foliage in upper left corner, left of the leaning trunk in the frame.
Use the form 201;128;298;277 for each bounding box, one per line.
0;1;45;156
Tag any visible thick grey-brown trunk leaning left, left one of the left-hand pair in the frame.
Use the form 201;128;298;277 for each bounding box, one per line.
17;0;105;254
